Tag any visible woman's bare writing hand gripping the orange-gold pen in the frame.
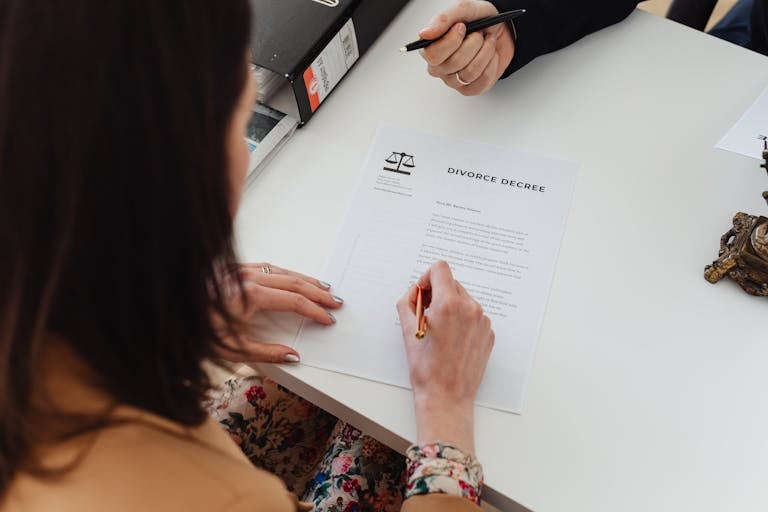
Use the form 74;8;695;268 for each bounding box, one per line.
397;261;494;452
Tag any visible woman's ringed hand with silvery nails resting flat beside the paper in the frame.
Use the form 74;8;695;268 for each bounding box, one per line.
214;263;344;363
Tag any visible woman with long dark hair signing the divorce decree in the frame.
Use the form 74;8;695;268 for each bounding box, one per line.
0;0;493;512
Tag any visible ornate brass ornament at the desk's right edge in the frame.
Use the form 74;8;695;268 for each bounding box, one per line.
704;135;768;297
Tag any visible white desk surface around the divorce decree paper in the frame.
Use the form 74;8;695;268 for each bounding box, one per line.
237;5;768;512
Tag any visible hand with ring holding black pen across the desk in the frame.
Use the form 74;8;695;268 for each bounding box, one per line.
406;0;524;96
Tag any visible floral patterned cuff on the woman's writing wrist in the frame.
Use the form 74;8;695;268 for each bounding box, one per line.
405;441;483;505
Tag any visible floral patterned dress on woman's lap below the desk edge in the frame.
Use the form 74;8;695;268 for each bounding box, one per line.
208;374;406;512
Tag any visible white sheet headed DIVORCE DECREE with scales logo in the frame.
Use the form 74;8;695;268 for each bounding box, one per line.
297;127;576;413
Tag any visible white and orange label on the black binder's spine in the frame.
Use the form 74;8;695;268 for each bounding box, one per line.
304;18;360;112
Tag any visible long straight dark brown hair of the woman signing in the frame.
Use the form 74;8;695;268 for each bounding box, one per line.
0;0;250;497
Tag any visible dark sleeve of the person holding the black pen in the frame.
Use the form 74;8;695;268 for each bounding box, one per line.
490;0;640;78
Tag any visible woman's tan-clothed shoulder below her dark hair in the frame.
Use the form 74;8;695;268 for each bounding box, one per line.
0;414;296;512
